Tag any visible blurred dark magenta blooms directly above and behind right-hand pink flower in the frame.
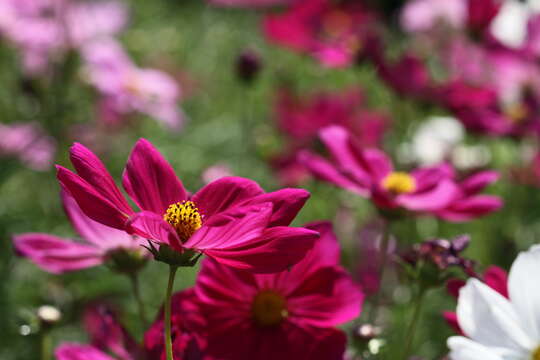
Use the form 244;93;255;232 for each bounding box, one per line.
272;89;390;184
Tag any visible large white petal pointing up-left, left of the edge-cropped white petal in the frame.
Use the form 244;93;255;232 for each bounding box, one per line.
457;279;537;354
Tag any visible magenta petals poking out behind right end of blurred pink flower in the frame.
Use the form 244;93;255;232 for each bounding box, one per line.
435;171;503;222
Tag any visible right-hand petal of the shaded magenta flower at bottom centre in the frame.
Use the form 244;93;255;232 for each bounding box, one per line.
287;267;364;327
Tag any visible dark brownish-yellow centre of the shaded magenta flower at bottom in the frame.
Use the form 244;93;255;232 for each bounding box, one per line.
251;290;289;326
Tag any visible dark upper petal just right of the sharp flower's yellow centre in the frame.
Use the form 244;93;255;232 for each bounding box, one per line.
191;176;264;218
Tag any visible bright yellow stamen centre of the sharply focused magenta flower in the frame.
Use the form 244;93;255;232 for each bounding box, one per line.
163;200;202;241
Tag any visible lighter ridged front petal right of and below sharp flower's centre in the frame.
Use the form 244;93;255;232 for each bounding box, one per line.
184;203;272;253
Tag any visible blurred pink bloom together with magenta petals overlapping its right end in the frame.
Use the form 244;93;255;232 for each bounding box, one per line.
301;126;502;221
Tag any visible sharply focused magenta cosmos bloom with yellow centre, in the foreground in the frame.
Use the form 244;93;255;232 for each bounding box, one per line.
57;139;318;272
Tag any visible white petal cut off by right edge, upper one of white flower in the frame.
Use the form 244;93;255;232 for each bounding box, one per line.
508;246;540;341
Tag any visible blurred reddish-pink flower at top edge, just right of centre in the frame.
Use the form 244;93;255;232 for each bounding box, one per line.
264;0;376;67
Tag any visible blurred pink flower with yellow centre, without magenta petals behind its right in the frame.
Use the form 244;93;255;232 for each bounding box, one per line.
302;126;458;213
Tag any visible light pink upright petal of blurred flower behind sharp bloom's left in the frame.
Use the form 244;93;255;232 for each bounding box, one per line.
60;191;135;249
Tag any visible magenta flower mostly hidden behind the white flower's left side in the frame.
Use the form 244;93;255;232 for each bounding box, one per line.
443;265;508;335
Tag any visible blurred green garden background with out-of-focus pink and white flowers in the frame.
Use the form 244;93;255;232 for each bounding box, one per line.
0;0;540;360
